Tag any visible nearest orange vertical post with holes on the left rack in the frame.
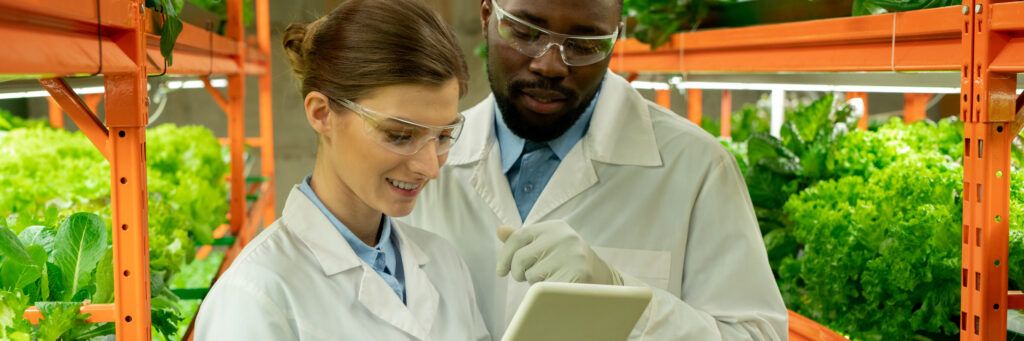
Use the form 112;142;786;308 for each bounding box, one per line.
104;0;152;341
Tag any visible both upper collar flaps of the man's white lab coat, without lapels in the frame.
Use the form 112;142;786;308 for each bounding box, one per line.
447;71;662;166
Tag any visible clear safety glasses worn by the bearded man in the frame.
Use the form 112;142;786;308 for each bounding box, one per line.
490;0;618;67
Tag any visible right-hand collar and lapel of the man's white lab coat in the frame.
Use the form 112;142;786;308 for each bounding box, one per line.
524;72;662;224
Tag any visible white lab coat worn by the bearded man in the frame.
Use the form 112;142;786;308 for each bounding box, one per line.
403;73;786;341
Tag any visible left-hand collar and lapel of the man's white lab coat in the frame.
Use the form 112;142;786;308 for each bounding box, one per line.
447;95;522;226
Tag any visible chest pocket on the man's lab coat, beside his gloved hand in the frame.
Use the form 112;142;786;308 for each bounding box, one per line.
593;247;672;291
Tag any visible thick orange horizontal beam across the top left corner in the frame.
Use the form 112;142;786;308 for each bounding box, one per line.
0;0;269;78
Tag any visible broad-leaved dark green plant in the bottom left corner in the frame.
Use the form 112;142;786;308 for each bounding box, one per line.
0;213;114;340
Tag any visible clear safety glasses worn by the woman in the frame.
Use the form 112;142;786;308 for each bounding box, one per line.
334;99;466;156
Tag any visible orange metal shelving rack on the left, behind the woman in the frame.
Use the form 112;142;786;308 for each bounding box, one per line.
0;0;274;340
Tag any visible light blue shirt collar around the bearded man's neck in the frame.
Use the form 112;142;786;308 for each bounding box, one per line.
495;81;603;173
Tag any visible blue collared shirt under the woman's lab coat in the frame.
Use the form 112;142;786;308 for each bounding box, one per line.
299;175;406;302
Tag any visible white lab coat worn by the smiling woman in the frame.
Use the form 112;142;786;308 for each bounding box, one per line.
196;188;489;341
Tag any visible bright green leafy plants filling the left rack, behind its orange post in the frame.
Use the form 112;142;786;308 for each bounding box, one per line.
0;125;227;339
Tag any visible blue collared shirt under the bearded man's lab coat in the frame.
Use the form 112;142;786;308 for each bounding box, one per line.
495;88;601;220
